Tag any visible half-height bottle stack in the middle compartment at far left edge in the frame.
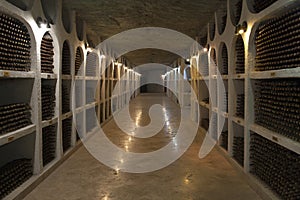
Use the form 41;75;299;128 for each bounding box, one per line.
0;103;32;135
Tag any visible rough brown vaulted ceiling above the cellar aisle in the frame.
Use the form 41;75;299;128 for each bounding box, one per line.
63;0;226;65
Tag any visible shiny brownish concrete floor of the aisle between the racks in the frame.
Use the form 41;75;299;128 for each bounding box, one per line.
25;95;260;200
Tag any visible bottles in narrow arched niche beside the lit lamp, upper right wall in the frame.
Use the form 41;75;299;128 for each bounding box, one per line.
235;35;245;74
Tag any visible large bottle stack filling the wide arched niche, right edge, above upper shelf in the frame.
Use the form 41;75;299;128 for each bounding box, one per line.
255;6;300;71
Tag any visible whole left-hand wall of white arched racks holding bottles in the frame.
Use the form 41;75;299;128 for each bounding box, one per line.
0;1;140;199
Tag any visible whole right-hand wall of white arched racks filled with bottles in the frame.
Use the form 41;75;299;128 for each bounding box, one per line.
186;0;300;199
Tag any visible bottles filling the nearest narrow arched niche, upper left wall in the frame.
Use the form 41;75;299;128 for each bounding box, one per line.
41;33;54;73
